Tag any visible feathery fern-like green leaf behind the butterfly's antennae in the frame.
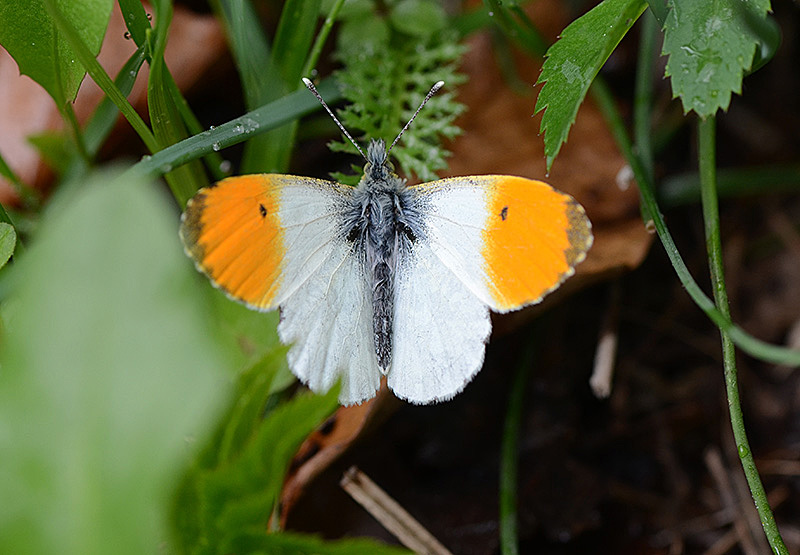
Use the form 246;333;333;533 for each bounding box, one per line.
331;0;466;182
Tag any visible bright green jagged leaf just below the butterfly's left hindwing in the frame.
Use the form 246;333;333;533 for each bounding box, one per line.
174;384;339;555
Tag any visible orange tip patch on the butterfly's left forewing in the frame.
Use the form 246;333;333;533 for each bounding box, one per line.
181;175;285;310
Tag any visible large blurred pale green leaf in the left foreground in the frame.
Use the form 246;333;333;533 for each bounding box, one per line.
0;169;228;555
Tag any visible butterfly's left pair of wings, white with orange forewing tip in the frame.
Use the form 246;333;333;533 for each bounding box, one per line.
181;175;380;404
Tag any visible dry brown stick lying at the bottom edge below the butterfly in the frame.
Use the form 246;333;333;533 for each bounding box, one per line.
339;466;452;555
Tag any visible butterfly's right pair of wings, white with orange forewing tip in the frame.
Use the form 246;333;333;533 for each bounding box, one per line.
388;176;591;403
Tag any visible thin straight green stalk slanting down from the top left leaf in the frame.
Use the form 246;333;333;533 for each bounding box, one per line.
44;0;158;152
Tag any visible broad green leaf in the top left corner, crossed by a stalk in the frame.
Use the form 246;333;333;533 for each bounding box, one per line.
0;0;113;106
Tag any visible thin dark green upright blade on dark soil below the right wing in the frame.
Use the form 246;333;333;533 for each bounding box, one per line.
500;347;533;555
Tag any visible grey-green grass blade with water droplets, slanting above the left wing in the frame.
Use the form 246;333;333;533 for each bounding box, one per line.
129;79;342;184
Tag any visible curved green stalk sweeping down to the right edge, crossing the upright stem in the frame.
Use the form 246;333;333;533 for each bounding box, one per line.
589;78;800;366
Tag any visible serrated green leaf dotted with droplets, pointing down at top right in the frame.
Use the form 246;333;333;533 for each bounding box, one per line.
663;0;770;118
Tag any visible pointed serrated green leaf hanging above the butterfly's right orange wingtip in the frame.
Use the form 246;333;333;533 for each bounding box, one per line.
534;0;647;170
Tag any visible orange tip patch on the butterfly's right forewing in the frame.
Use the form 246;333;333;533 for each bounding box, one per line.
483;176;592;311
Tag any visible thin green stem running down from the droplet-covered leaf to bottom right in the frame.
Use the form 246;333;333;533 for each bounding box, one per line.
698;116;789;555
